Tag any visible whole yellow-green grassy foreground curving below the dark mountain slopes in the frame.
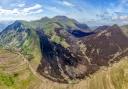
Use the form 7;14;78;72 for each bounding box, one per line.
0;49;128;89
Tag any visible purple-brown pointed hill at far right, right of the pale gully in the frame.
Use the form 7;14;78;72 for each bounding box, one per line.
82;25;128;66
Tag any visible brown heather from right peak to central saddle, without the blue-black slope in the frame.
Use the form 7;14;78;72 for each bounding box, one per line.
53;25;128;74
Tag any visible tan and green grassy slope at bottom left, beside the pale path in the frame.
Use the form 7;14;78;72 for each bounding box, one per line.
0;49;40;89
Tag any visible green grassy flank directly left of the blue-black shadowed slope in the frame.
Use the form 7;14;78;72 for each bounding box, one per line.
21;29;42;69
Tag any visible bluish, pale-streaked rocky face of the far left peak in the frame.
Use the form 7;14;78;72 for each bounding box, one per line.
0;21;27;47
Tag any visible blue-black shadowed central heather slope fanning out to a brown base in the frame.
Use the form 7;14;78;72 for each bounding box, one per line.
37;30;86;81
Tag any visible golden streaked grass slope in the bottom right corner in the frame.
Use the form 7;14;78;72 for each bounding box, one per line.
87;58;128;89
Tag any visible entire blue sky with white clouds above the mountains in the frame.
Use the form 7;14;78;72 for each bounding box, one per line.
0;0;128;24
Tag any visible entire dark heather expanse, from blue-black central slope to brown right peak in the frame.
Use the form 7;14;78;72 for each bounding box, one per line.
37;25;128;82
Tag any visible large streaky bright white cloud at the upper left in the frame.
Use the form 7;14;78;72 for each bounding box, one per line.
0;4;43;20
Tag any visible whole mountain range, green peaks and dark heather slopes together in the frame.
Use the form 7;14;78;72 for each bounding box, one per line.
0;16;128;83
